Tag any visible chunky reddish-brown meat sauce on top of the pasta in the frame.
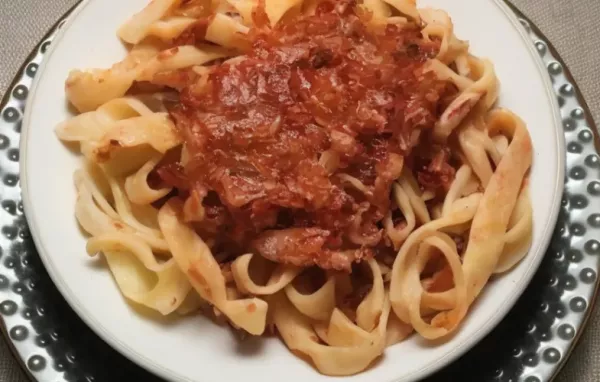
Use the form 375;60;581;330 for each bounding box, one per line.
152;2;456;271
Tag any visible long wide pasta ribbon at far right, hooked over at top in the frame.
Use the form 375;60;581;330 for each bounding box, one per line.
408;109;532;325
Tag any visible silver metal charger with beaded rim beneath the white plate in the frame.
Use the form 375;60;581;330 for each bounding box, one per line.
0;4;600;382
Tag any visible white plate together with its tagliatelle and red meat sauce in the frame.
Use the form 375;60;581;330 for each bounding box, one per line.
21;0;564;381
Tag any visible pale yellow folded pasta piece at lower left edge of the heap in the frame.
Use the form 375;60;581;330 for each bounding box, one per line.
86;232;192;315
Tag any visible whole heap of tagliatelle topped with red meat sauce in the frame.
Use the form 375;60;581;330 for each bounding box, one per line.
56;0;533;375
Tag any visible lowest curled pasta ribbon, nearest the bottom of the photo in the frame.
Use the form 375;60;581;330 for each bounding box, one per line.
271;293;390;375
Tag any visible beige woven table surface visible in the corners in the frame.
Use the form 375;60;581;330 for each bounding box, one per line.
0;0;600;382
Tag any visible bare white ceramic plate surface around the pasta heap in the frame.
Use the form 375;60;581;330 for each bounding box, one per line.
21;0;564;382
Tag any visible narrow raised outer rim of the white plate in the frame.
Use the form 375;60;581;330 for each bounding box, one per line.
15;0;568;382
